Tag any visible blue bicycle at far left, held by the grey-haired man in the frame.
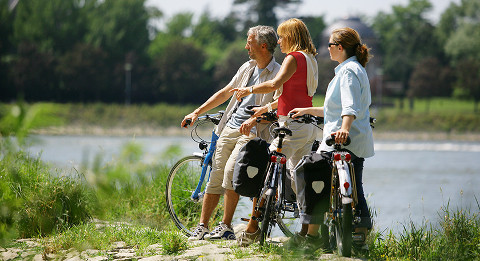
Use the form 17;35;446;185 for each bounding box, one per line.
165;111;224;237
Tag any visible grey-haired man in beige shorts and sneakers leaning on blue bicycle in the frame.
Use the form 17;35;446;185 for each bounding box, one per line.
181;25;281;240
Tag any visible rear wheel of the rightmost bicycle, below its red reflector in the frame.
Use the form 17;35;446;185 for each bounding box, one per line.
335;201;352;257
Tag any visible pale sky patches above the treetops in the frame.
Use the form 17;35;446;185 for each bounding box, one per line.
146;0;461;23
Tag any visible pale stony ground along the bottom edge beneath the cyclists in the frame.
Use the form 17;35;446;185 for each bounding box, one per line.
0;220;366;261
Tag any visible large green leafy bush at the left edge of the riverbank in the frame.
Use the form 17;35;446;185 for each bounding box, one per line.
0;139;95;240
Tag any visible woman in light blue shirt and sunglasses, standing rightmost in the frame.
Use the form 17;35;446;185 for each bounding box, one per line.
291;28;374;247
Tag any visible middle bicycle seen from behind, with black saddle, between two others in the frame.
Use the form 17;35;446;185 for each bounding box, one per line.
252;112;323;245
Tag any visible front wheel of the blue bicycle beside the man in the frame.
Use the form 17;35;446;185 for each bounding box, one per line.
165;155;223;236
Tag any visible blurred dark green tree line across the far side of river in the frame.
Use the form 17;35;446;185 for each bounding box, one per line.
0;0;480;110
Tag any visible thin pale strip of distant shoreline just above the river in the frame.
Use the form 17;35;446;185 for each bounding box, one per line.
31;126;480;142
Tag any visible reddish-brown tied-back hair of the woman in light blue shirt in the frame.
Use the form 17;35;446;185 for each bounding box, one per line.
332;27;373;67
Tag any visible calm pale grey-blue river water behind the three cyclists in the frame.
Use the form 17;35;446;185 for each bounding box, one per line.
25;135;480;233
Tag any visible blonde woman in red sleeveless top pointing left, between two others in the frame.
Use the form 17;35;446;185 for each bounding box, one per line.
231;18;318;245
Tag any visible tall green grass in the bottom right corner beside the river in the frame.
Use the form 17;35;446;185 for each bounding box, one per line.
368;205;480;260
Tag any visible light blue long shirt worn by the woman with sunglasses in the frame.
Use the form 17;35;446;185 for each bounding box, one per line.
319;56;375;158
